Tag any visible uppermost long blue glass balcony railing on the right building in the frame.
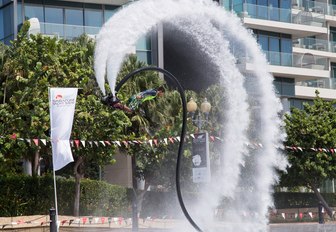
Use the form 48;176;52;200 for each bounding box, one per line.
233;3;326;27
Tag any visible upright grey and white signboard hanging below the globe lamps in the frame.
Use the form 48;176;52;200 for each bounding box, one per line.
192;132;211;183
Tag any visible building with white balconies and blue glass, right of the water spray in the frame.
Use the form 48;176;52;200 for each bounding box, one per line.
220;0;336;108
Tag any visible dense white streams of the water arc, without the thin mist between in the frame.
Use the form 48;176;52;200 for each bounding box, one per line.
95;0;285;232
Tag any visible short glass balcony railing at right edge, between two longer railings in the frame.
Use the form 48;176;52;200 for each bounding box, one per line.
293;38;336;53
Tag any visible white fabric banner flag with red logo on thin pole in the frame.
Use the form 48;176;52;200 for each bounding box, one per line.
49;88;77;171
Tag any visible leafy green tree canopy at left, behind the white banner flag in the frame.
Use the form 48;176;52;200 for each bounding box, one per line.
0;22;131;173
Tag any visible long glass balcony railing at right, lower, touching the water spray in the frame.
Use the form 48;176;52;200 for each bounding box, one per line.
264;51;329;70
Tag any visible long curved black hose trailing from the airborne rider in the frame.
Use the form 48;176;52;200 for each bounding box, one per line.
115;66;202;232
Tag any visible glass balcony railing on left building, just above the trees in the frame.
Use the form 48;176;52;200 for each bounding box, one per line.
40;23;100;40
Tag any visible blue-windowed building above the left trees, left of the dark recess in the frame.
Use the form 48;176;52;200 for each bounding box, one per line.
0;0;152;63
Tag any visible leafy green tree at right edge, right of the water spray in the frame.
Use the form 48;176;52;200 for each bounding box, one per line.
281;93;336;189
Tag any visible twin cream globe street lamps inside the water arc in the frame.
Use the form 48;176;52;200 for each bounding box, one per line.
187;98;211;130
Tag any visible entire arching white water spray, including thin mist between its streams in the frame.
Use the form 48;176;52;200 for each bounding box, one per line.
95;0;286;232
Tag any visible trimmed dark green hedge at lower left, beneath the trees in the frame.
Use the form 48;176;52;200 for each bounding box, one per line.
0;175;130;217
